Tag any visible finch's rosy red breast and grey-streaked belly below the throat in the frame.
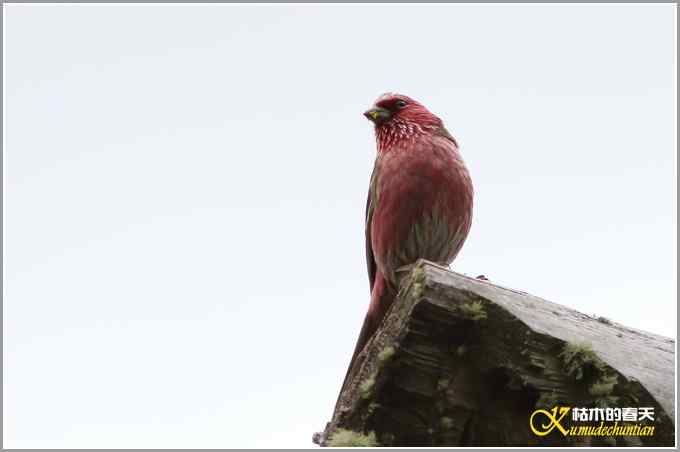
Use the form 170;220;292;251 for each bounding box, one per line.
367;133;472;284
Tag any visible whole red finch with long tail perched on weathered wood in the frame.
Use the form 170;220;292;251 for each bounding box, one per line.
343;93;473;392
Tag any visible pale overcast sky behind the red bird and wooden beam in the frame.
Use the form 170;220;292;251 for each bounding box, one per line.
2;4;676;448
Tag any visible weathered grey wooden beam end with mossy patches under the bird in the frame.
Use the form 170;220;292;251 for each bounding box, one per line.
315;261;675;446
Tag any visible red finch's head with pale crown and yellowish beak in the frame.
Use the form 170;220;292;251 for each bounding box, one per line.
364;93;441;128
